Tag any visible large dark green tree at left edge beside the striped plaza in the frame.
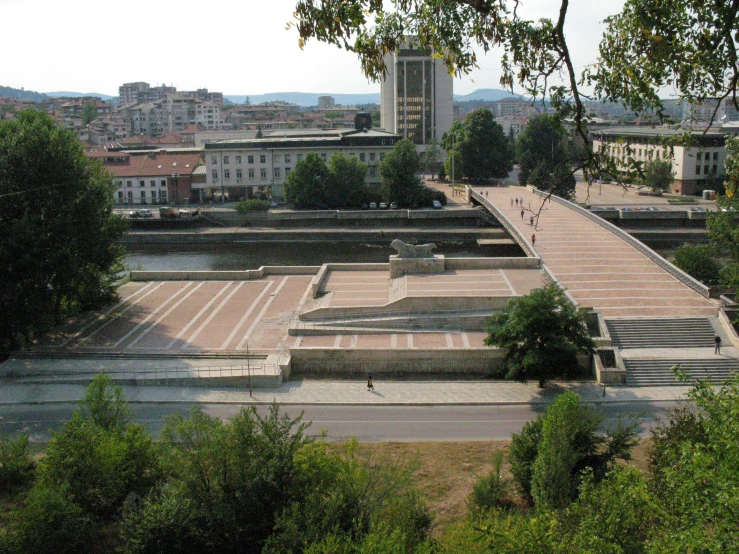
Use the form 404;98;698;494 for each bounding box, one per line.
0;110;127;350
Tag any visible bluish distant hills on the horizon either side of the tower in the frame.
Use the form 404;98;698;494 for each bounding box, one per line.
225;88;516;107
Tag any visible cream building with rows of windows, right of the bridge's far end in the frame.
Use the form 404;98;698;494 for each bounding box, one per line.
593;127;726;195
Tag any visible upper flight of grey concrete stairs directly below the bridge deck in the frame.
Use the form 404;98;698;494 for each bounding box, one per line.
606;317;716;348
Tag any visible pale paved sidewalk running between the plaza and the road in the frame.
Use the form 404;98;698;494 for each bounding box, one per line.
0;379;690;406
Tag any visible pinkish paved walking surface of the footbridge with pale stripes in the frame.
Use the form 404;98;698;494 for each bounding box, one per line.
484;187;718;317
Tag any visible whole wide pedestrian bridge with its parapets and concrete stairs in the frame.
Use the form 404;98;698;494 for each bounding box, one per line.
468;187;739;385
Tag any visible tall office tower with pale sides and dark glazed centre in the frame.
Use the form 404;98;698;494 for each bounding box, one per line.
380;44;454;150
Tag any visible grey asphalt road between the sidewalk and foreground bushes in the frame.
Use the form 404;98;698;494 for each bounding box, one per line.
0;402;675;442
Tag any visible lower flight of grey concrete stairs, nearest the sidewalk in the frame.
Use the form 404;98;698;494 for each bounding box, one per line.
624;358;739;386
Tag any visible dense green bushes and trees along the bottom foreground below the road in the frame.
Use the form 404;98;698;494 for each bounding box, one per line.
0;375;739;554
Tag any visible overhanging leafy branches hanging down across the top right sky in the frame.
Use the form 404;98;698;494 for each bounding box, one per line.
289;0;739;192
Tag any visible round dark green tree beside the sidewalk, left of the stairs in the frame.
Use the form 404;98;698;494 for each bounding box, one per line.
485;284;595;387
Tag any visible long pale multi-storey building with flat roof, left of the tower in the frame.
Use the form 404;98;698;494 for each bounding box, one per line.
204;119;401;201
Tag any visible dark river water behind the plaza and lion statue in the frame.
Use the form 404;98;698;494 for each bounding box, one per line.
125;242;523;271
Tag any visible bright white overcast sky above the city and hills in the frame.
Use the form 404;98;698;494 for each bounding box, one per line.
0;0;623;95
